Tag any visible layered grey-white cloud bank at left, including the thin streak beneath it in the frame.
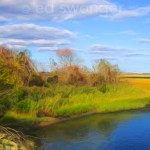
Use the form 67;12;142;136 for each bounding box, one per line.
0;24;77;48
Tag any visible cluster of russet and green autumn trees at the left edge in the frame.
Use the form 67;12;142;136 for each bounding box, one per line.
0;47;37;90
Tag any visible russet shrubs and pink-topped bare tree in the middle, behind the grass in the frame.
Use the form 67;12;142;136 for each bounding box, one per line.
50;48;120;86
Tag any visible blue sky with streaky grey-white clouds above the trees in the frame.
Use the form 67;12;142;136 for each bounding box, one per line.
0;0;150;73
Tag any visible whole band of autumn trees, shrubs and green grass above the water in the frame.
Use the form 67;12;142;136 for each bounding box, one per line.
0;47;150;149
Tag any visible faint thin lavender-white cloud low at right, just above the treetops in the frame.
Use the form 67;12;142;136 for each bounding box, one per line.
88;44;150;60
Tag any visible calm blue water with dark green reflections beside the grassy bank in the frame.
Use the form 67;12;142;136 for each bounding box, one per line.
36;112;150;150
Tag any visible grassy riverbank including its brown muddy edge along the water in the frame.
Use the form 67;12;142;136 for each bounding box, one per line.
0;82;150;150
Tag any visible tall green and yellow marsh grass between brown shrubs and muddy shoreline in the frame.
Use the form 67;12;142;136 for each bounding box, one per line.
1;83;150;123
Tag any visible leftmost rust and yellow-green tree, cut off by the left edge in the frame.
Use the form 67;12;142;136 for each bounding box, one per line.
0;47;22;95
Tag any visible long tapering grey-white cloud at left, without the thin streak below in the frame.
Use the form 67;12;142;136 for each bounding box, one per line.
0;24;76;39
